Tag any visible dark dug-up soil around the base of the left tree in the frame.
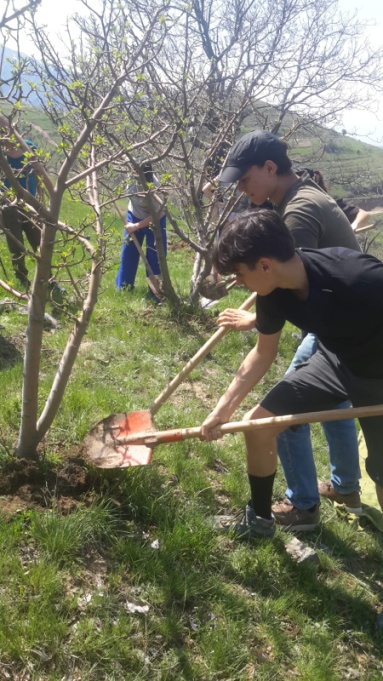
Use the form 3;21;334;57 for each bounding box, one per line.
0;456;95;515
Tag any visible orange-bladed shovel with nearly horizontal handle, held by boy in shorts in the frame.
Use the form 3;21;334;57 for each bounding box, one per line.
84;404;383;468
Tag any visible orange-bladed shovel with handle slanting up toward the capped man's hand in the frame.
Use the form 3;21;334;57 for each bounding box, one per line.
85;293;257;468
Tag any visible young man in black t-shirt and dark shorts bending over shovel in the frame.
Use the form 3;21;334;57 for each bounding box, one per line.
202;210;383;539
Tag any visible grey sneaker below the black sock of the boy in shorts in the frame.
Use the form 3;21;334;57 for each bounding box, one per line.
214;505;275;541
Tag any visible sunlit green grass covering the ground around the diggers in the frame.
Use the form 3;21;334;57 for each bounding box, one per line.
0;199;383;681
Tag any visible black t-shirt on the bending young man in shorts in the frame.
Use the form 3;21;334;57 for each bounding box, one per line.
256;248;383;378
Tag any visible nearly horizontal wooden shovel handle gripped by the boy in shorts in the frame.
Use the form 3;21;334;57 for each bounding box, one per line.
117;404;383;447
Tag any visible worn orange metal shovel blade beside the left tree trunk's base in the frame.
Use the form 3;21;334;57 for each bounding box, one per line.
84;410;154;468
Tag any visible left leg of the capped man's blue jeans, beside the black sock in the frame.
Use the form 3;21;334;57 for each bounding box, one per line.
277;333;319;509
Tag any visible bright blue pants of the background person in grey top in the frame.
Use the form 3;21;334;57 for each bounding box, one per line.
116;211;167;290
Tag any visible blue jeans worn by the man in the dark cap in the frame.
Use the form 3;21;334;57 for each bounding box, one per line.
277;333;361;510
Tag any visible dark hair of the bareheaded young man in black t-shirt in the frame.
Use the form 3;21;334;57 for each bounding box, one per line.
213;208;295;274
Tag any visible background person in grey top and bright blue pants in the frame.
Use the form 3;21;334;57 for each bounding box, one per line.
116;163;167;295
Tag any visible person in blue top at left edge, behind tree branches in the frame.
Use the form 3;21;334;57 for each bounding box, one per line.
1;140;41;288
